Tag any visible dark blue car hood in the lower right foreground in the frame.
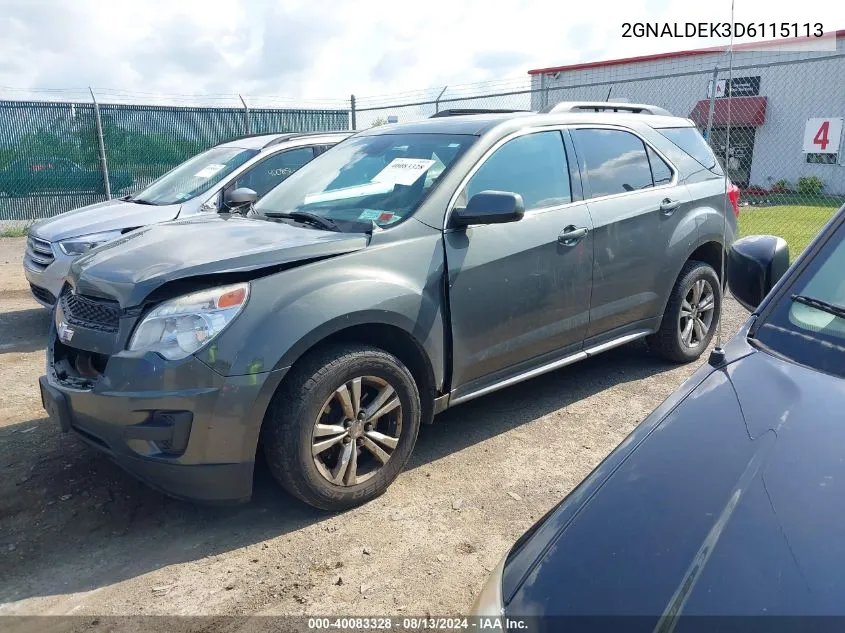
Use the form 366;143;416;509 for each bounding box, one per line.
504;352;845;616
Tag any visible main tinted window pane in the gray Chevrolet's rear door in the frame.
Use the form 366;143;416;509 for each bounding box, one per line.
575;130;652;198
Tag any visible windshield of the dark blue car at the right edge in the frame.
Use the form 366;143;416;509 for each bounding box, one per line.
755;217;845;377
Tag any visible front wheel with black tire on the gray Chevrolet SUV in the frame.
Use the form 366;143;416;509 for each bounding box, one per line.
262;345;421;512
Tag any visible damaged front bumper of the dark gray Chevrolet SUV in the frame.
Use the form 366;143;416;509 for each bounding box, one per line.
40;314;284;503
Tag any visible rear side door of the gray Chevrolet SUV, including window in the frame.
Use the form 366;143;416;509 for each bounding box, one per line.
572;126;690;345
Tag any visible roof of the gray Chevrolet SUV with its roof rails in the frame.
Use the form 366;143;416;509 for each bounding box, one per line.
359;112;695;136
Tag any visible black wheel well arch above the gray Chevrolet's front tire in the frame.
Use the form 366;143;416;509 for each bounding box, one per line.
278;323;437;424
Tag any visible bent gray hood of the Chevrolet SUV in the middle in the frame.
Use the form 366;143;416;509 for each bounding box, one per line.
68;215;368;307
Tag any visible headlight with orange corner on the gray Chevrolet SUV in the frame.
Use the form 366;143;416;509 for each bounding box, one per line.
128;283;249;360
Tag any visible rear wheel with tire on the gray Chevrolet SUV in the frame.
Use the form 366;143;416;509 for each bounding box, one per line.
646;260;722;363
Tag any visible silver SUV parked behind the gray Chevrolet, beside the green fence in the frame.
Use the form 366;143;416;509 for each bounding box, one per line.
23;132;350;307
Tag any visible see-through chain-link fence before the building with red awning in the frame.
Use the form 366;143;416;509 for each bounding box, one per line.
353;43;845;255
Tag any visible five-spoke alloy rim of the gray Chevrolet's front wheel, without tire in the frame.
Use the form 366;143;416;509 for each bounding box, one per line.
311;376;402;486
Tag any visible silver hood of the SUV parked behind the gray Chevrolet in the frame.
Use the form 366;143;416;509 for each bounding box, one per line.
30;200;180;242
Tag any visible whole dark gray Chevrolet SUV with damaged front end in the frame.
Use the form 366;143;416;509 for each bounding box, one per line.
41;104;737;510
